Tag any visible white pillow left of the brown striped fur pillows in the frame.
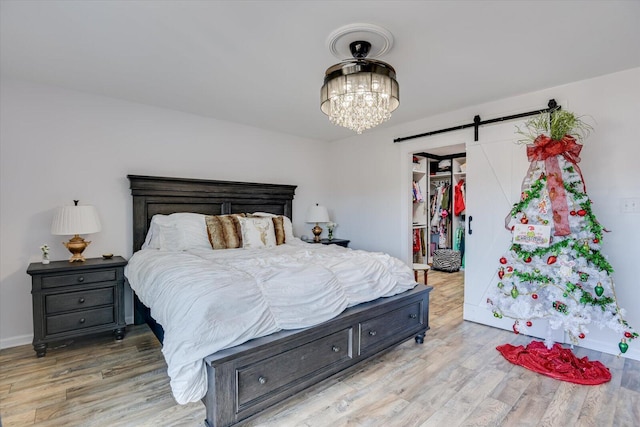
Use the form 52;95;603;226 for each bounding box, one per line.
142;212;211;251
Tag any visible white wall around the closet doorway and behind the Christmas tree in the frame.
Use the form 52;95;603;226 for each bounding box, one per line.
329;68;640;360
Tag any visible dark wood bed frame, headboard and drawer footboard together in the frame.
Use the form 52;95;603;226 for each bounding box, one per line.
128;175;432;427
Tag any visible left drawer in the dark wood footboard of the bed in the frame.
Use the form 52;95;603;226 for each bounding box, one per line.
237;328;353;411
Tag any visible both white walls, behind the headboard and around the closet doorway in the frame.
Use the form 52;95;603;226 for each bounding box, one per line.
5;68;640;358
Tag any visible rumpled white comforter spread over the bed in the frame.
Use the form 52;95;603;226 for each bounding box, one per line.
125;239;416;404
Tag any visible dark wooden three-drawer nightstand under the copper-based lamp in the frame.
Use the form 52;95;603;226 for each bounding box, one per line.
27;256;127;357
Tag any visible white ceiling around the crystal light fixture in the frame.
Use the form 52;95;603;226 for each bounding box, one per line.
0;0;640;141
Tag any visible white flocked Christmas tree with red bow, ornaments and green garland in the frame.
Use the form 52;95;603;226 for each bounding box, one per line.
487;110;638;353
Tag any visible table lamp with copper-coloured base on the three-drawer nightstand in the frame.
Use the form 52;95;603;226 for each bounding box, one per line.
51;200;101;262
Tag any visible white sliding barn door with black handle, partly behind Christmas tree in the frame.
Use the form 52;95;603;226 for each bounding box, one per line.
463;122;564;342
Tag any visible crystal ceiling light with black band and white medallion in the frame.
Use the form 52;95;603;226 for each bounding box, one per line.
320;24;400;134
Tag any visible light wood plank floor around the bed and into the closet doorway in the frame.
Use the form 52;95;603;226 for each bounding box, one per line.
0;271;640;427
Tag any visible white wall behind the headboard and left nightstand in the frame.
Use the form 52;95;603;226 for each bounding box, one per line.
0;80;330;348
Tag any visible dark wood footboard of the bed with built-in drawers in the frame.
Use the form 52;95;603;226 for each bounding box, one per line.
202;285;432;427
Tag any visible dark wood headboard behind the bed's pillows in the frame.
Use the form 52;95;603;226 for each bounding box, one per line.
127;175;296;252
